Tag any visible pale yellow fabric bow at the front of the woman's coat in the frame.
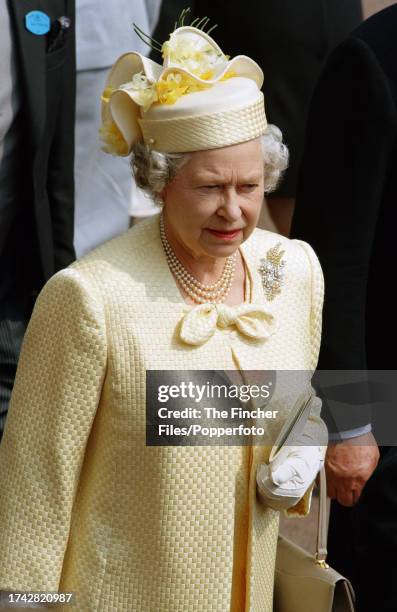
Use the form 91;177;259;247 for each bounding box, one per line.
180;304;275;345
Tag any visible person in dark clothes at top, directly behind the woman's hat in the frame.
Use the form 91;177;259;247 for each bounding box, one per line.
153;0;362;236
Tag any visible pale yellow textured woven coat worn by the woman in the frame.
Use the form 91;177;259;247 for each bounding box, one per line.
0;217;325;612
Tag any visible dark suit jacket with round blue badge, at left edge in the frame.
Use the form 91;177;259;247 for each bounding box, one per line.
0;0;75;294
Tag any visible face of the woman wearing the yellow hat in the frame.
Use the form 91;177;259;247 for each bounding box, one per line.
161;138;264;259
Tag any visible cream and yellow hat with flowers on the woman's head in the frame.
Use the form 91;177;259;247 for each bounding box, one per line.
100;26;267;156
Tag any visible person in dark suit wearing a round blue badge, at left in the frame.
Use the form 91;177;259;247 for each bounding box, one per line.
0;0;75;438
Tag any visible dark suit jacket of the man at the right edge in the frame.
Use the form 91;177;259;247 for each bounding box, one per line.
292;5;397;426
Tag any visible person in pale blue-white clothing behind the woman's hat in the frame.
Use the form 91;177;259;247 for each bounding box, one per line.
74;0;159;257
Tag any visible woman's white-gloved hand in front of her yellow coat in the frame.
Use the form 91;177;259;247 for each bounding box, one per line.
256;445;326;510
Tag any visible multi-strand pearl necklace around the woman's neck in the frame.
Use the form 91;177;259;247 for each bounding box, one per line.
160;215;237;304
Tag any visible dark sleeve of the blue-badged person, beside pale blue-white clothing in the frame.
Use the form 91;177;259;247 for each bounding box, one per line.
47;0;76;272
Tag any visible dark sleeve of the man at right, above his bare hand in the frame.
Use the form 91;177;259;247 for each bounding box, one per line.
292;37;395;429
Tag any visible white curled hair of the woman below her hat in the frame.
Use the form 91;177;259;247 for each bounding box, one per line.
131;125;289;206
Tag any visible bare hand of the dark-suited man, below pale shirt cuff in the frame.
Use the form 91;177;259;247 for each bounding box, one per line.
325;433;379;506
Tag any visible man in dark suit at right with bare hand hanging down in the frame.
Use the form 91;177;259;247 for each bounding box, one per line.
292;4;397;612
